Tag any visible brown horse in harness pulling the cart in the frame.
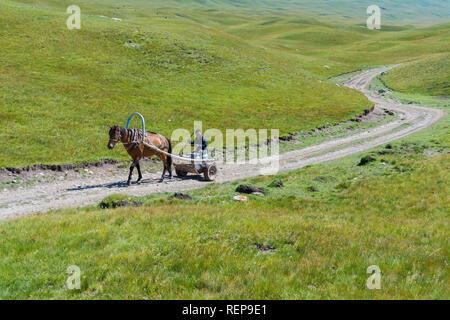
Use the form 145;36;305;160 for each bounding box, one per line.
108;126;172;185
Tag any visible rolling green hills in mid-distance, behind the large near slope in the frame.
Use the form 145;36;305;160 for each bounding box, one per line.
227;17;450;76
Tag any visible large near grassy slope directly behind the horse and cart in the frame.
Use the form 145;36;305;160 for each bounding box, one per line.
0;2;369;166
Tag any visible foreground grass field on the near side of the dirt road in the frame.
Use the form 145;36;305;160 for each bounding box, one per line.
0;112;450;299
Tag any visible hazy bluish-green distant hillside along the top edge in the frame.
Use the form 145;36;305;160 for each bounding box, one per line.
14;0;450;24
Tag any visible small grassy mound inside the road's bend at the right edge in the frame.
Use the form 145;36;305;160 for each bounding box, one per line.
383;53;450;96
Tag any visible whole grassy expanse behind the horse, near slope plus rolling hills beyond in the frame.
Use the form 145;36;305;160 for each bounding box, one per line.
0;0;449;167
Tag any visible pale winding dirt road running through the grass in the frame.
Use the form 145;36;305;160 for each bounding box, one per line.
0;67;445;220
